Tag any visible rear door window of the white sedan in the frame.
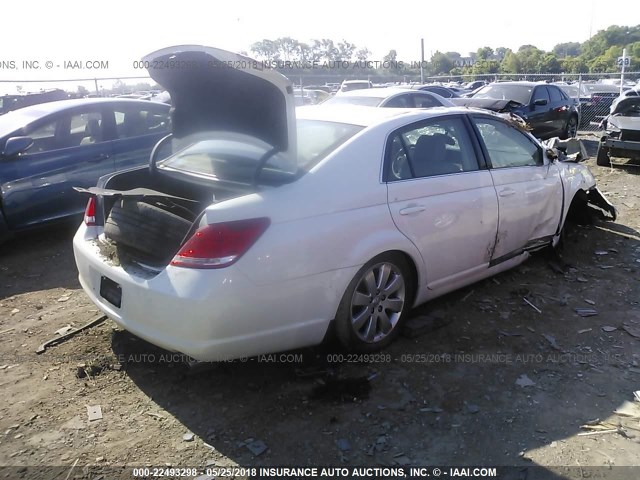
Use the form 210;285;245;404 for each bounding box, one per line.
385;117;479;181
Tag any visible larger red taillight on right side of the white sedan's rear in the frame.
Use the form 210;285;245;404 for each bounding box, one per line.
171;218;271;268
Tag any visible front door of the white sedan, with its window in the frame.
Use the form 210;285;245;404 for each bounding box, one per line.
471;115;563;264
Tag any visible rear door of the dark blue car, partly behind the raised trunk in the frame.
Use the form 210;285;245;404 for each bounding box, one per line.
113;102;171;170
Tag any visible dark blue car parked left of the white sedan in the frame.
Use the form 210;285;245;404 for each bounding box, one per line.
0;98;171;241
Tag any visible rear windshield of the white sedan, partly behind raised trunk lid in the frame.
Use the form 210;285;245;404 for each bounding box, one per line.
158;120;364;185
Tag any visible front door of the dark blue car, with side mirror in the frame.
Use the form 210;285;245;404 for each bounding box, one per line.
1;105;114;229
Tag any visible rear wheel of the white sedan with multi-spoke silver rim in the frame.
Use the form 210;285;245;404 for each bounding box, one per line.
336;253;413;352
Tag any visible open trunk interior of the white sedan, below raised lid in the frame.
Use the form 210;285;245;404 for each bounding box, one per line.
98;167;254;277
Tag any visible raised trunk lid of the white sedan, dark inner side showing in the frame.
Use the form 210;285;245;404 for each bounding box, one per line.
142;45;296;159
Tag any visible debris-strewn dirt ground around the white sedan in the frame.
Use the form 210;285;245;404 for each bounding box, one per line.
0;137;640;479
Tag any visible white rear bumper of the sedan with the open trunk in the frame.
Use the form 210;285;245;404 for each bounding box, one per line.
73;225;340;361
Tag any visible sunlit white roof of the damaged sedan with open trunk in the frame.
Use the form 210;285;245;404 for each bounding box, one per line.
296;104;482;127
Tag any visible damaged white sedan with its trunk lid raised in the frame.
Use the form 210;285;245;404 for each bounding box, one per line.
73;46;615;360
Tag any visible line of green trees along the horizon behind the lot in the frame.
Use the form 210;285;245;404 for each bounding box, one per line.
250;25;640;76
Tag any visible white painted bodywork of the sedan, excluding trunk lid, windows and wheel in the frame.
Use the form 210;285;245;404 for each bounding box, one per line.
73;102;608;360
